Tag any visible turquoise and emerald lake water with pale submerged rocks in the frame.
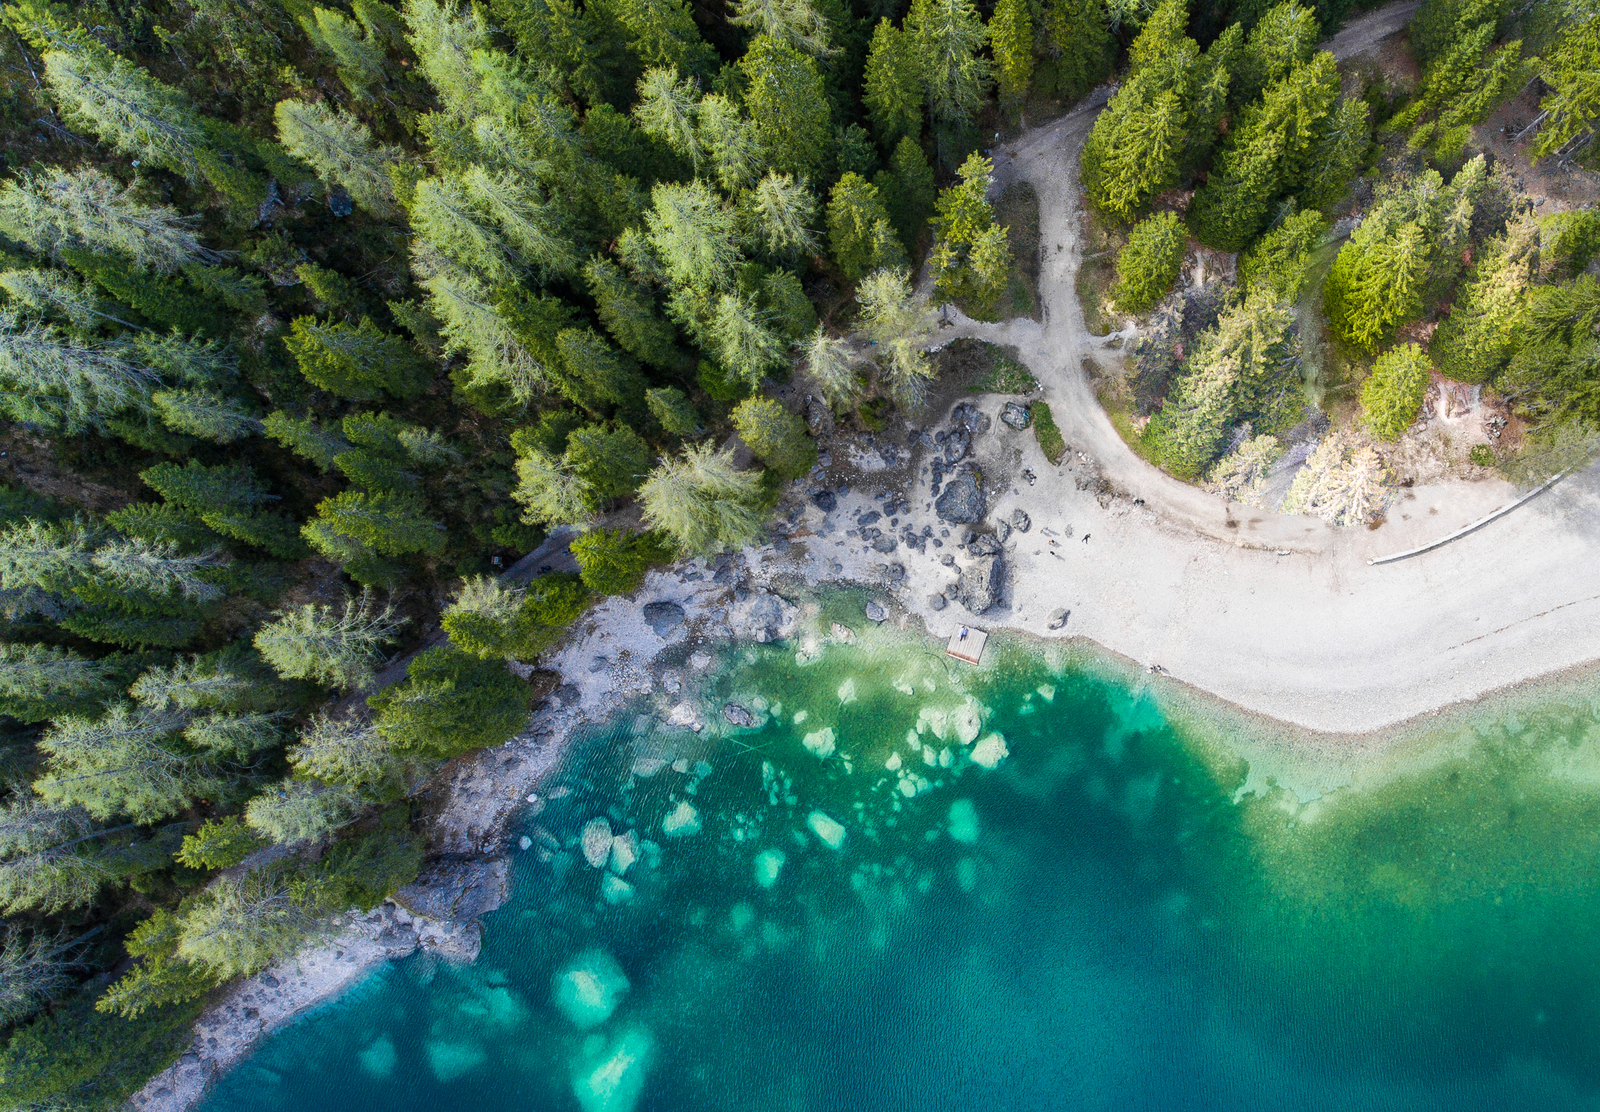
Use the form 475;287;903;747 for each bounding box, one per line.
203;617;1600;1112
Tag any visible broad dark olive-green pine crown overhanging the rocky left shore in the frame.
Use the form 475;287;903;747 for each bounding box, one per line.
366;648;528;758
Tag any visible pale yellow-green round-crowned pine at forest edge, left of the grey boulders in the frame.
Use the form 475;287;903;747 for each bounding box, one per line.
638;445;762;555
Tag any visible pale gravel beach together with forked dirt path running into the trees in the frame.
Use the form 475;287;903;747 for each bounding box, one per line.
907;0;1600;733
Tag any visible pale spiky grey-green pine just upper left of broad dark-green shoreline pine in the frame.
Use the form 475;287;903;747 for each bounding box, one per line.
254;590;406;691
